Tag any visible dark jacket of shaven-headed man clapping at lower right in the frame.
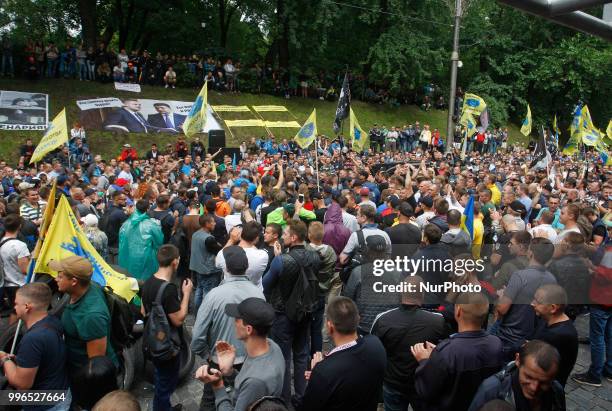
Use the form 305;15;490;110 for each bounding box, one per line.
415;330;503;411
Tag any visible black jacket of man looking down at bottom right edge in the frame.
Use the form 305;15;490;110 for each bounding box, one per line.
469;362;565;411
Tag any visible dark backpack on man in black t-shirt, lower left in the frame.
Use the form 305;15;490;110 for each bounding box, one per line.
142;281;181;361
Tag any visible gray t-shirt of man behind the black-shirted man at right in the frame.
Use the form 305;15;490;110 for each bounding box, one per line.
498;266;557;348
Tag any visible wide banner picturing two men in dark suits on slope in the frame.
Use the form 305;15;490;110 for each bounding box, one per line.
77;97;223;134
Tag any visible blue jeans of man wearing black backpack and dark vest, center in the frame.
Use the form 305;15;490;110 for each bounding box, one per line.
271;311;311;403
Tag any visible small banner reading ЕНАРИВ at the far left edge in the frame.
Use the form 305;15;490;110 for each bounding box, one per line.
0;90;49;131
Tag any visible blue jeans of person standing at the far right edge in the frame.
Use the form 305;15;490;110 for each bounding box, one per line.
589;306;612;379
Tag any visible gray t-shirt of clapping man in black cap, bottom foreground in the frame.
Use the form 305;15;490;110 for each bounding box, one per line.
215;339;285;411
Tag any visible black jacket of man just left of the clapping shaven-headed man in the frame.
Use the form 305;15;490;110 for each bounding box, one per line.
372;304;448;394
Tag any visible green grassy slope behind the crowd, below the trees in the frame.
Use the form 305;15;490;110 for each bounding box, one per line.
0;79;524;163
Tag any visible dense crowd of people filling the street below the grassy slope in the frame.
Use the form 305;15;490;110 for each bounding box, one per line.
0;122;612;411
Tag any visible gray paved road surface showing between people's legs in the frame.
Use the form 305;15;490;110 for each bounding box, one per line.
132;316;612;411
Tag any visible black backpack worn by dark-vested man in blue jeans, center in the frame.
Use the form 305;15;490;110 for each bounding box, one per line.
285;251;319;323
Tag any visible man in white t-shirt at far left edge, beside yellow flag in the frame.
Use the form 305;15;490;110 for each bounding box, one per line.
0;214;30;324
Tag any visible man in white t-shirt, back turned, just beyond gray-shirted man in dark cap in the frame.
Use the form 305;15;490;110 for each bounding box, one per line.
215;221;268;291
